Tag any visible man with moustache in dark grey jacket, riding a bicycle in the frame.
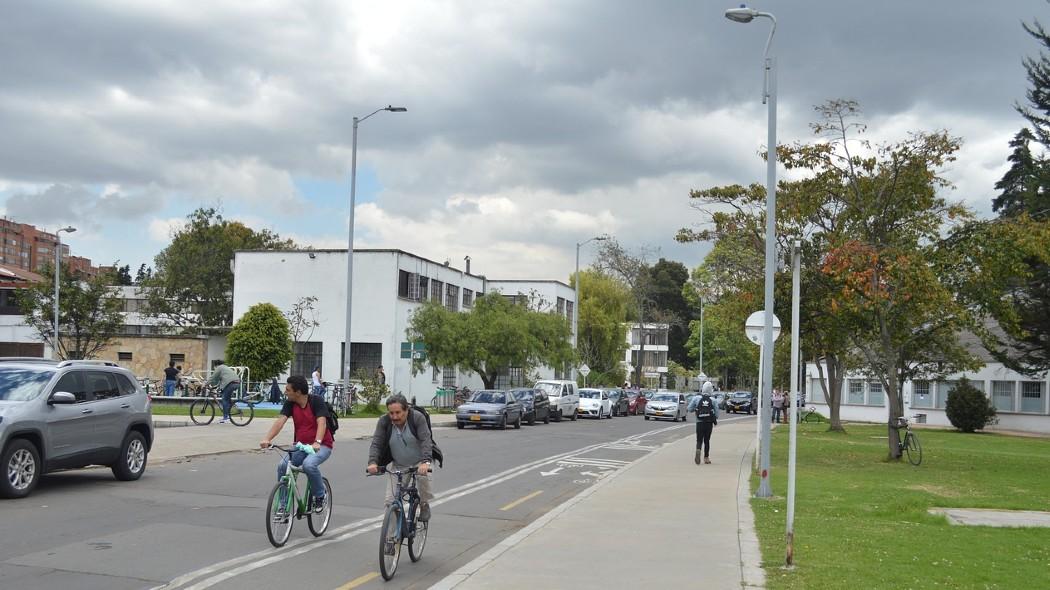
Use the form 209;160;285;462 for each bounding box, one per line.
369;394;434;523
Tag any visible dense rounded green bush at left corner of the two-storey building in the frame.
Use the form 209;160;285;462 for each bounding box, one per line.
226;303;292;381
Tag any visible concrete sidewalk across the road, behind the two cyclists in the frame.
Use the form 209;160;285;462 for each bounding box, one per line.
149;414;456;463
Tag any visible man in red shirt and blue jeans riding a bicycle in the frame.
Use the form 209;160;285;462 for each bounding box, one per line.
259;375;335;512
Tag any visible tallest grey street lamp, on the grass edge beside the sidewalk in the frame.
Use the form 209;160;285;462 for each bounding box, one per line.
726;5;777;498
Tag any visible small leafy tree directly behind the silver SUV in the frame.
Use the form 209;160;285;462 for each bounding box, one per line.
18;266;124;359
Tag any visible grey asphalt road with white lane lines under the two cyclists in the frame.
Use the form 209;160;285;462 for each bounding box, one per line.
0;417;694;590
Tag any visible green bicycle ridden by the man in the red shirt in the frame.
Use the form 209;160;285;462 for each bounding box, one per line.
266;443;334;547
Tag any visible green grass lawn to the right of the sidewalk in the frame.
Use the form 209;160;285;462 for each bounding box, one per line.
751;424;1050;590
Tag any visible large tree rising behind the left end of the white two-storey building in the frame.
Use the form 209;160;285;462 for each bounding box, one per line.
144;208;296;328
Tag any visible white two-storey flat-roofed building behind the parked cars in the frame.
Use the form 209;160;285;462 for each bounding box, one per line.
233;250;574;403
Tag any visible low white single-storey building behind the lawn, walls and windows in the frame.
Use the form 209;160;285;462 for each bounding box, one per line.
805;347;1050;434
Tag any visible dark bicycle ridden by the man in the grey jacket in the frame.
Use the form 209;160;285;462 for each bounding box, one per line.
369;464;431;581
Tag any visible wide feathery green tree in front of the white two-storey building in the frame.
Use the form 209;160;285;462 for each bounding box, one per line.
405;292;573;389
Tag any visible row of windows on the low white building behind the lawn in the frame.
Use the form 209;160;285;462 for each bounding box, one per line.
810;379;1048;414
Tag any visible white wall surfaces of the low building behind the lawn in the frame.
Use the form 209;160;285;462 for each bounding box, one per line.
806;362;1050;434
